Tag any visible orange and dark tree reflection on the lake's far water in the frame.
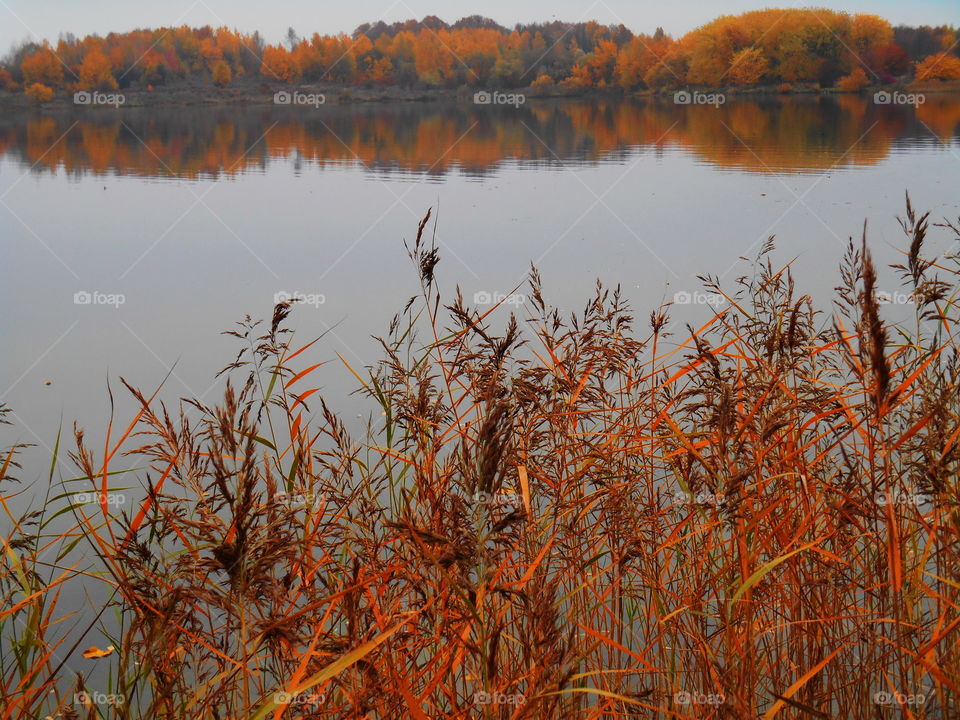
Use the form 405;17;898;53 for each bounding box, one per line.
0;95;960;179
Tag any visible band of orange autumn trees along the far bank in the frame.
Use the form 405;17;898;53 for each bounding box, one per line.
0;9;960;100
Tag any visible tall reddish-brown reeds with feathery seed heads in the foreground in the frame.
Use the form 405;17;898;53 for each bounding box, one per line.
0;194;960;720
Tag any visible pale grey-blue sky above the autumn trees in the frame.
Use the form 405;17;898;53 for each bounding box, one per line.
0;0;960;54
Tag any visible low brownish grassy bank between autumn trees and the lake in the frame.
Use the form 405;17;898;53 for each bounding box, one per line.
0;81;960;111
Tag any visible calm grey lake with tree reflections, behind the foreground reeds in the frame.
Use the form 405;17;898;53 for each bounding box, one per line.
0;95;960;480
